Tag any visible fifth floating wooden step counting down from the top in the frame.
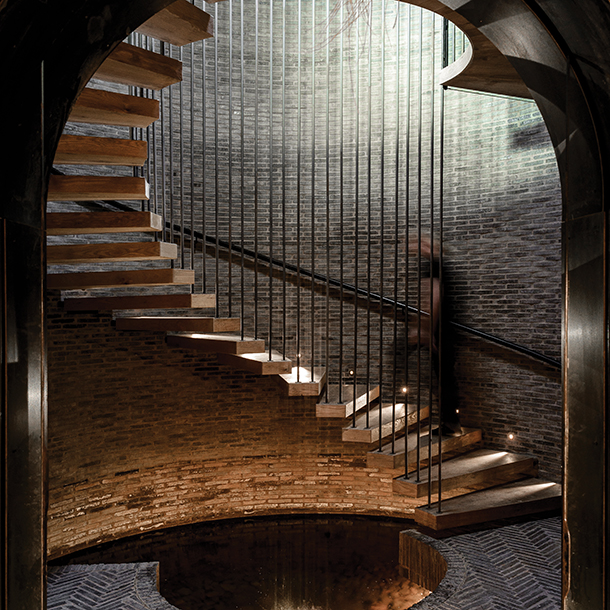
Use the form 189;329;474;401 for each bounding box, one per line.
47;176;149;201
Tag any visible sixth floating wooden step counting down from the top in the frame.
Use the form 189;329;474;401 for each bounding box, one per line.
47;212;163;235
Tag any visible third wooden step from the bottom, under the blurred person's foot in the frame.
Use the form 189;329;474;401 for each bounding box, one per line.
366;428;481;469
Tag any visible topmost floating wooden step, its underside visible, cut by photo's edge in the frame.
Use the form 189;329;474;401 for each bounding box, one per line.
136;0;214;47
